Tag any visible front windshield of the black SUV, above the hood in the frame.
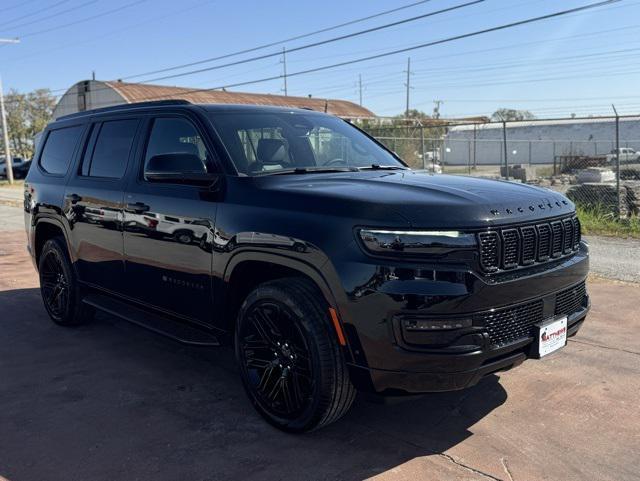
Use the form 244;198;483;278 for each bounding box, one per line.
211;112;404;175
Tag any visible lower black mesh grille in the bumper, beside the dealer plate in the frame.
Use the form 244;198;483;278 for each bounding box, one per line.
474;282;587;347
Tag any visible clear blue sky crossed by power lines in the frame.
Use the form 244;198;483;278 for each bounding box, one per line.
0;0;640;117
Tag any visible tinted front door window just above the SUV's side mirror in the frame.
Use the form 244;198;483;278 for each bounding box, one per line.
144;118;211;171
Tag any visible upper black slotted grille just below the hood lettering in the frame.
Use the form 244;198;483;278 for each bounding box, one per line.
478;217;580;273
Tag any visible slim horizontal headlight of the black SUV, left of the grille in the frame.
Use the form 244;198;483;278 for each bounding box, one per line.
359;229;476;255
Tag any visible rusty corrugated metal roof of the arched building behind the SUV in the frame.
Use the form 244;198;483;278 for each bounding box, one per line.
104;82;375;118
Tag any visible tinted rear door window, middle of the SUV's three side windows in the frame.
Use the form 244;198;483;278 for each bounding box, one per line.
82;119;138;179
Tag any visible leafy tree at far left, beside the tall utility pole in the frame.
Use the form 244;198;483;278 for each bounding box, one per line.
5;89;56;159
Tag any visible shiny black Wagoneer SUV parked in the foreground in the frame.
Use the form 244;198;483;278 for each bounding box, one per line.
24;101;589;432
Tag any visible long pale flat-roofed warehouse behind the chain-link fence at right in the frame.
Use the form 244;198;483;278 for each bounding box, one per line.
442;117;640;165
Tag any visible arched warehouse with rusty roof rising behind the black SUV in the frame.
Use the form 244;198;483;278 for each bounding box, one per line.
53;80;374;119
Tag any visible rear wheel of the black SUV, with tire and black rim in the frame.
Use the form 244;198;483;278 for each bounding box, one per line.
38;237;94;326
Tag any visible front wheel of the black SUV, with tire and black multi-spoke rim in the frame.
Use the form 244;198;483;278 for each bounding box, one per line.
235;278;355;432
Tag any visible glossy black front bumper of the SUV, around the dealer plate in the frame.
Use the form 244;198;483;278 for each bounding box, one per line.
343;240;590;395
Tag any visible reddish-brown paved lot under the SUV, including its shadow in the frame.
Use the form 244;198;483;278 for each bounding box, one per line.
0;203;640;481
